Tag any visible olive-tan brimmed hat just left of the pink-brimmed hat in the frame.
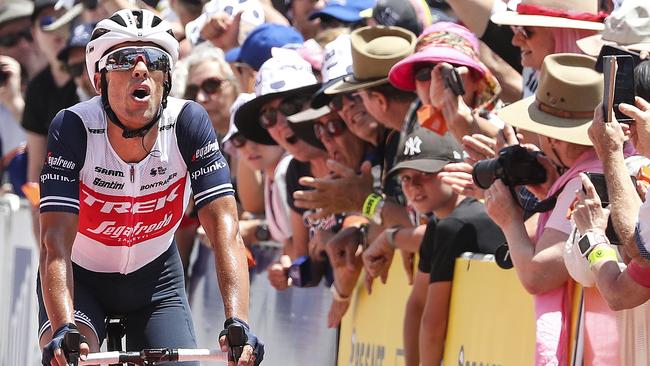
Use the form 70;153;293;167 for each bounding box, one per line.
325;26;417;94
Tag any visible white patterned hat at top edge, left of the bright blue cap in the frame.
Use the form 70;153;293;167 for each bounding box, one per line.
185;0;264;45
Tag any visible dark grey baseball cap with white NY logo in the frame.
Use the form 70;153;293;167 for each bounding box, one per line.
388;123;463;175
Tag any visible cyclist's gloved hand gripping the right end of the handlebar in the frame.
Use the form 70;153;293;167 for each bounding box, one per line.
219;317;264;366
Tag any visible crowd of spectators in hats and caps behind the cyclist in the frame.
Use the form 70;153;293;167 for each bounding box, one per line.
0;0;650;366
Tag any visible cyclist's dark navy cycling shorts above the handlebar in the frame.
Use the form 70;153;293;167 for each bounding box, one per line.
36;243;196;365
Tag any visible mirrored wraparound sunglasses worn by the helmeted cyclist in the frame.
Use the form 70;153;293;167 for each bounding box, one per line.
99;47;171;71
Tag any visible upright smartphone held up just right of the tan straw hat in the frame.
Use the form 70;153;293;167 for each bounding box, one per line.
602;55;635;124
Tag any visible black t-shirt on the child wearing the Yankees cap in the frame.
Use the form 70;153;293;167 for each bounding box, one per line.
418;198;505;282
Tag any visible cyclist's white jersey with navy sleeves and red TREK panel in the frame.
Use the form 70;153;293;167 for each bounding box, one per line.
40;97;234;274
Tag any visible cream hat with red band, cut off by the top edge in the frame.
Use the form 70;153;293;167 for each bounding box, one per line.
490;0;607;30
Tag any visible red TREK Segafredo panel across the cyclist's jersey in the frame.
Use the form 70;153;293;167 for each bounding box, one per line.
79;177;187;246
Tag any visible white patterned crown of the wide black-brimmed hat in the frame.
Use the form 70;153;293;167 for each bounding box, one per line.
254;48;318;97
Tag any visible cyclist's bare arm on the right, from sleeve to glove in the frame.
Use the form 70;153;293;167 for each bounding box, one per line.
198;195;248;322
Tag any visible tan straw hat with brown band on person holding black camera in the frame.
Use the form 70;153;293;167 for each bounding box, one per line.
498;53;603;146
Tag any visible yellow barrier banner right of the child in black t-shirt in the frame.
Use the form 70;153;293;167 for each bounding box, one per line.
444;256;535;366
